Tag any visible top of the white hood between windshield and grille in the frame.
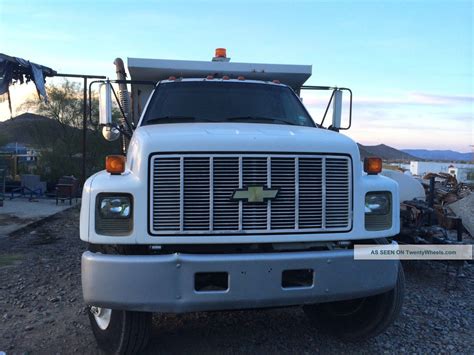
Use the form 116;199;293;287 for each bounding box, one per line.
130;123;359;158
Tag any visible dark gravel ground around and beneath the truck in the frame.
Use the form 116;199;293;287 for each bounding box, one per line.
0;208;474;354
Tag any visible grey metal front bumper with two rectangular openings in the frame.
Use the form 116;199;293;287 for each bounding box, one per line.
82;250;398;313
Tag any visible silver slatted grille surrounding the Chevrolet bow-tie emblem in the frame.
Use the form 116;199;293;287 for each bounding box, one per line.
150;154;352;235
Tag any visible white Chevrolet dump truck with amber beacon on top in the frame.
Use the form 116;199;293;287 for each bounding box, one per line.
80;49;404;353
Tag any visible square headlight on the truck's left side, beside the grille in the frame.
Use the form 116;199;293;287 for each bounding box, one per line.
95;193;133;236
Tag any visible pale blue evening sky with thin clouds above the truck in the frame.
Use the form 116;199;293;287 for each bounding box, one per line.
0;0;474;152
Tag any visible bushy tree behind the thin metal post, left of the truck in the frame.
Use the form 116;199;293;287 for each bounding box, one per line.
23;80;120;183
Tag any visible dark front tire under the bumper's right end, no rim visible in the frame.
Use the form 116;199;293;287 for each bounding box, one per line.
303;264;405;341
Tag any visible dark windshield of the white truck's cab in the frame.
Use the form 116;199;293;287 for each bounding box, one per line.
142;81;315;127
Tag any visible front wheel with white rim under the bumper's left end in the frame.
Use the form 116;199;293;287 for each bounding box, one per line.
89;306;152;354
